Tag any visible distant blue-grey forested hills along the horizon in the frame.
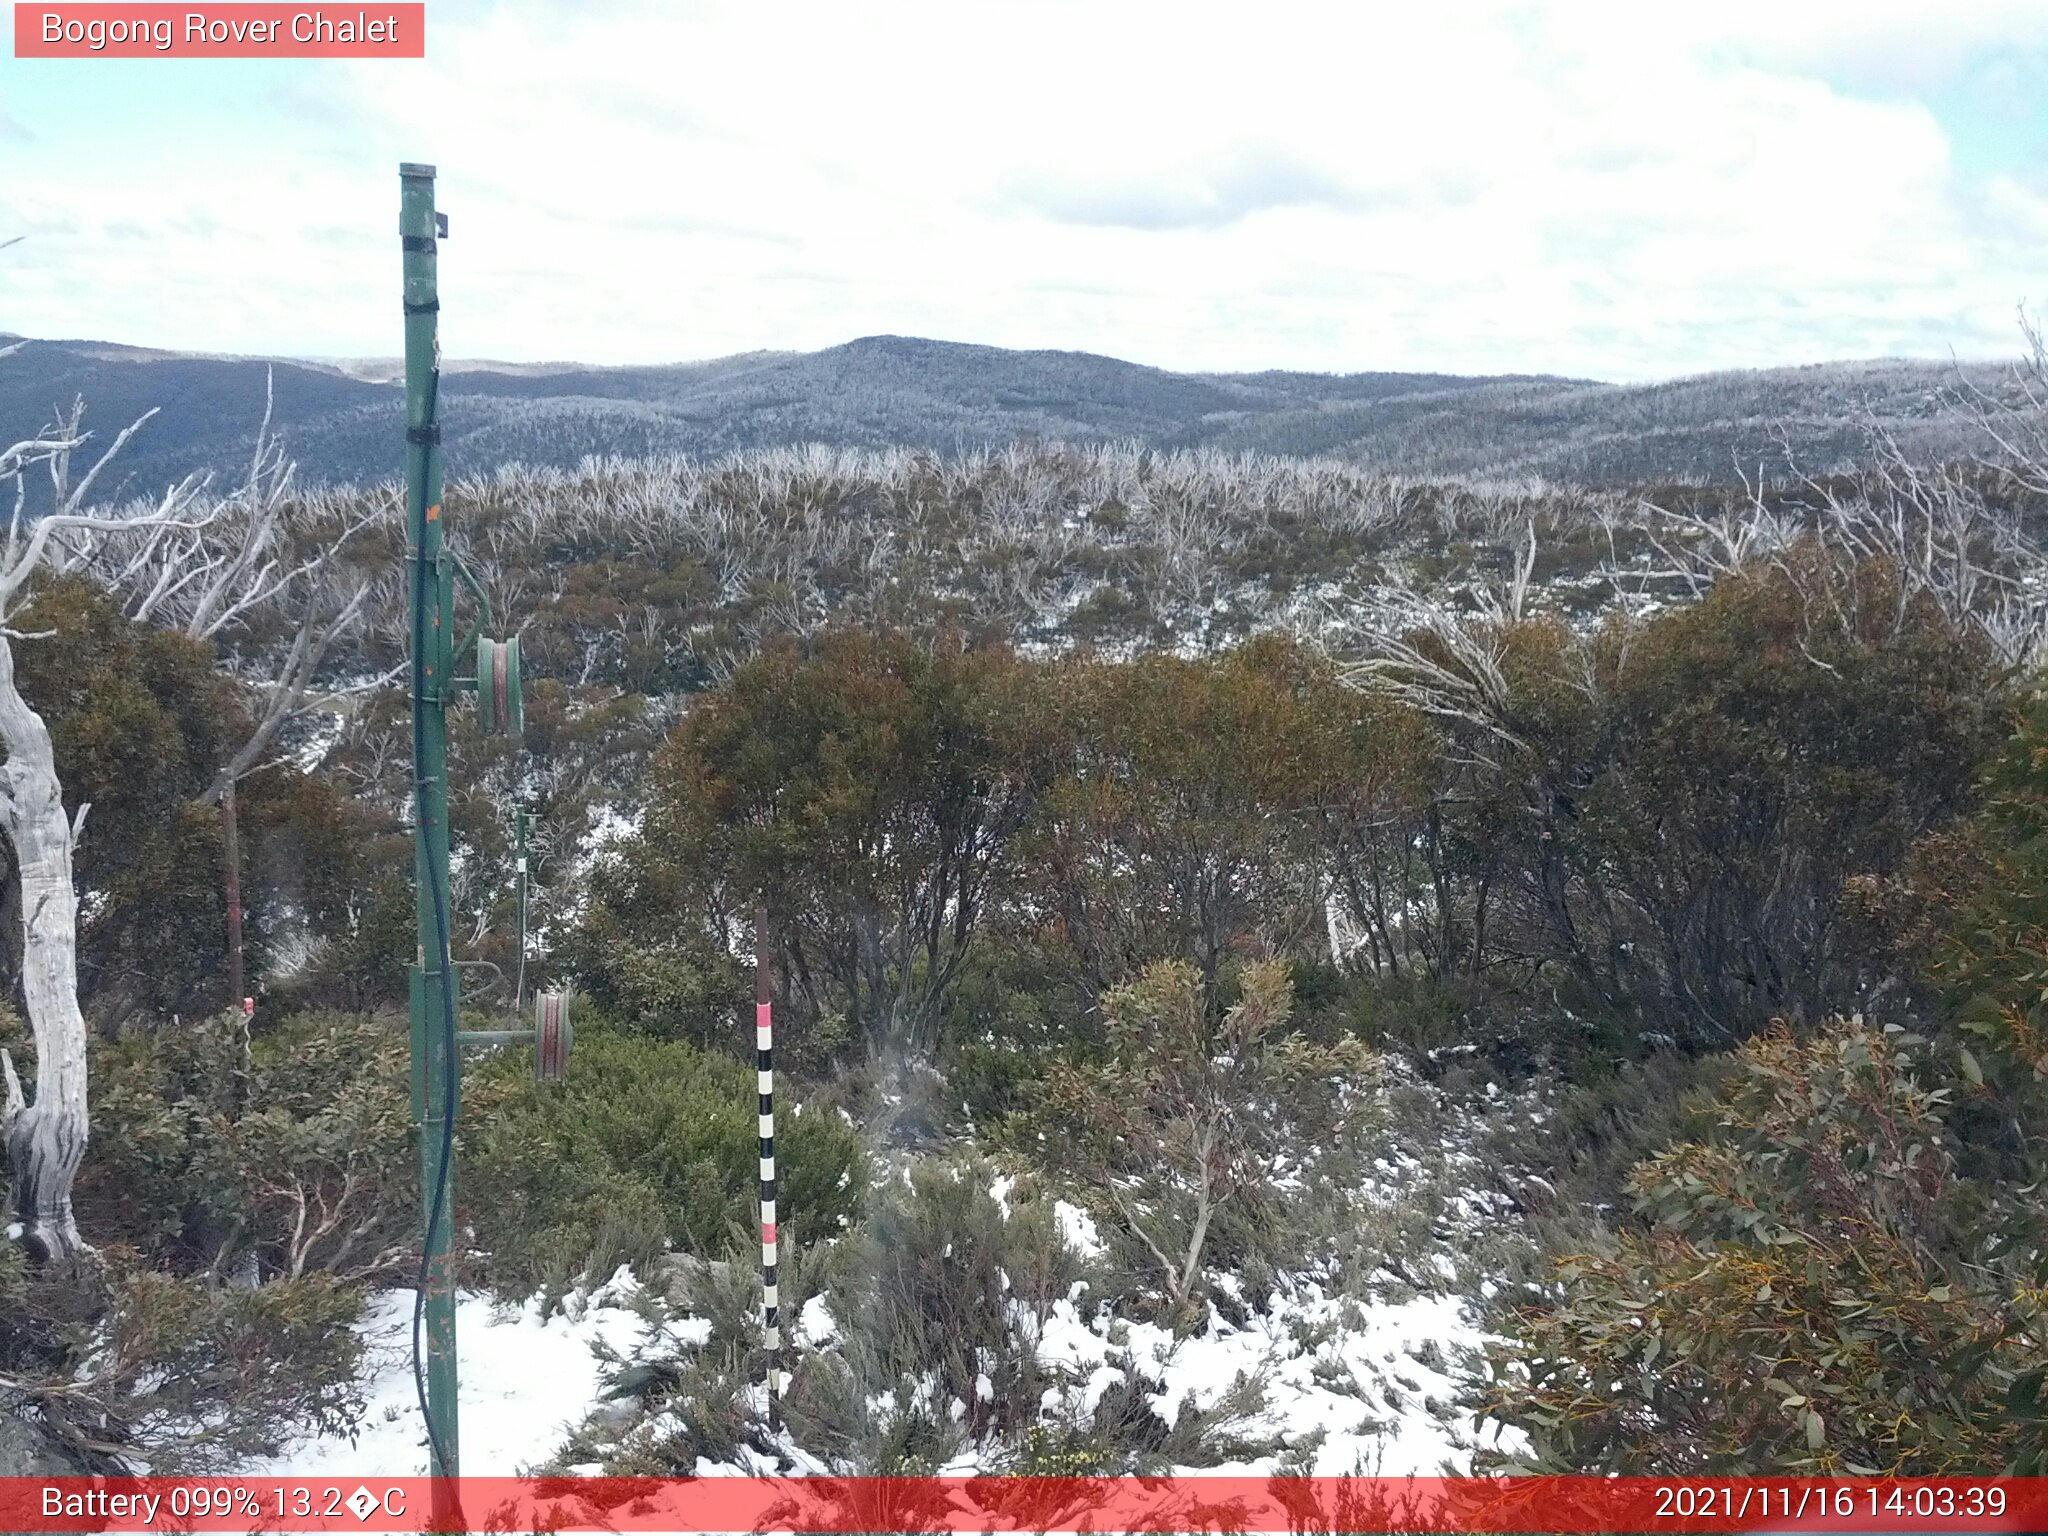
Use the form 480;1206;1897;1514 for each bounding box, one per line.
0;336;1999;492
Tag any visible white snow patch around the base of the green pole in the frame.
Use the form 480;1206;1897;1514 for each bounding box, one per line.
248;1272;684;1477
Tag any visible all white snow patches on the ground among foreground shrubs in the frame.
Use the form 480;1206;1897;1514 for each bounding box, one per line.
250;1073;1522;1477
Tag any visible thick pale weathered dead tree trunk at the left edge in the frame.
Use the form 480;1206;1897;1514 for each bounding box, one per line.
0;635;90;1268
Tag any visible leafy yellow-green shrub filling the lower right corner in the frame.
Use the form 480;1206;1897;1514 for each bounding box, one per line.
1487;1018;2048;1477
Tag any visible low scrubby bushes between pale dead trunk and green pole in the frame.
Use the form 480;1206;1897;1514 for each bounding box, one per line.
0;1016;382;1473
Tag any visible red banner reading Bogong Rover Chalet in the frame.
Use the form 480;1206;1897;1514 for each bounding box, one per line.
14;0;426;59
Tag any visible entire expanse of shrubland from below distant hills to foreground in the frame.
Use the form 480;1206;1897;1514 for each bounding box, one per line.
0;339;2048;1470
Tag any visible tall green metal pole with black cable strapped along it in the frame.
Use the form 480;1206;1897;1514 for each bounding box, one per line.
399;164;463;1530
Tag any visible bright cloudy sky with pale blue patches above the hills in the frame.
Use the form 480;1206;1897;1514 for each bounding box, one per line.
0;0;2048;381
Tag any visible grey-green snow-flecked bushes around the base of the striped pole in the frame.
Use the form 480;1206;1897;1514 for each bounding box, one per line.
559;1159;1081;1482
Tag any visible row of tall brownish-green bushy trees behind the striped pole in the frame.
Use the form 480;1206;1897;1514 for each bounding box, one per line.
573;565;2003;1089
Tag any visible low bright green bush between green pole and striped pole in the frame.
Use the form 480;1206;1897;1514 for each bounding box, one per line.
457;1020;866;1288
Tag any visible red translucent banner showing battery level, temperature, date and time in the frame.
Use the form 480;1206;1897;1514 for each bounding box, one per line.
0;1477;2048;1534
